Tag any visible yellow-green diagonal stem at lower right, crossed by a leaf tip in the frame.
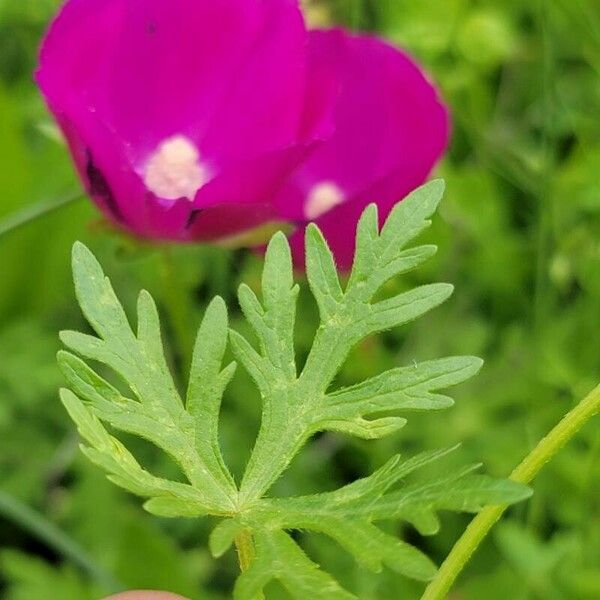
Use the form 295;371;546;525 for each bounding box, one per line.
421;385;600;600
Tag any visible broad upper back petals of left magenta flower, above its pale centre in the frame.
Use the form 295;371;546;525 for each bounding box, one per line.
38;0;306;156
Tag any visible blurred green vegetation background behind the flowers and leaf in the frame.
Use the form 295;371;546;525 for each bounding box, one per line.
0;0;600;600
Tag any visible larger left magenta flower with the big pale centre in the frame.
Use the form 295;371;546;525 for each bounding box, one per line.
36;0;333;240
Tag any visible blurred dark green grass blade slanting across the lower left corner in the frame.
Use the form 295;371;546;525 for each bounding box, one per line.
0;491;124;593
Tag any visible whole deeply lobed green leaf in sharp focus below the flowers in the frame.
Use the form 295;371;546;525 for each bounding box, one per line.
58;181;529;600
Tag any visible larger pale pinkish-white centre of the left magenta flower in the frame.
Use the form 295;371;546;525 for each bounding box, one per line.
144;135;209;201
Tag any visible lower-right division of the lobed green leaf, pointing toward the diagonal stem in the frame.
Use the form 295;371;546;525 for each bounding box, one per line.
240;448;530;581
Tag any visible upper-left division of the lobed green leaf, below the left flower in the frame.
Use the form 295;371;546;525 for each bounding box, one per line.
58;244;236;514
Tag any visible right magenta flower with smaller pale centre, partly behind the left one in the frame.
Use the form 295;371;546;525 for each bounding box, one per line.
278;30;449;268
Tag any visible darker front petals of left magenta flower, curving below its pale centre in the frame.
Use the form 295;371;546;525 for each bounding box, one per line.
61;109;311;241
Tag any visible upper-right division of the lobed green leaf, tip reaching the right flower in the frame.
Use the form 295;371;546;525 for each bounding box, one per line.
231;182;464;502
